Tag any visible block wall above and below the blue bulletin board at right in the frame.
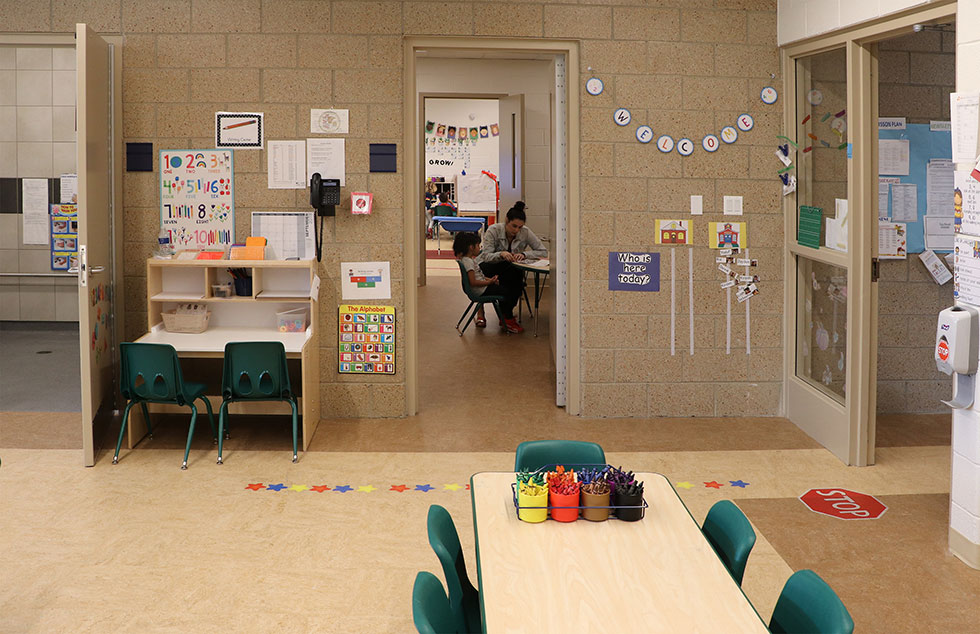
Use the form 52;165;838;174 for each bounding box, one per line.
877;31;956;413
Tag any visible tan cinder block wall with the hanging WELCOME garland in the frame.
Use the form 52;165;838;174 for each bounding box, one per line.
0;0;783;417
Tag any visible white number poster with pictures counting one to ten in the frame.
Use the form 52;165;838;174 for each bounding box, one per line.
160;150;235;249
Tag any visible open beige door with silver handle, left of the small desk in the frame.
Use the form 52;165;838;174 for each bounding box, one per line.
75;24;122;466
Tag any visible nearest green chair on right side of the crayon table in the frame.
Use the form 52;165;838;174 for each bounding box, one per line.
769;570;854;634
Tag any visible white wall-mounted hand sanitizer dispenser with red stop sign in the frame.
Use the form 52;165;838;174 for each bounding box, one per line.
936;306;980;409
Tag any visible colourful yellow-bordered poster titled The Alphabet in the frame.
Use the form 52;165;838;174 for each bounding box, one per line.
338;304;395;374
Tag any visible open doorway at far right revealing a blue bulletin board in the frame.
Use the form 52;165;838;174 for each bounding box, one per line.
873;23;956;447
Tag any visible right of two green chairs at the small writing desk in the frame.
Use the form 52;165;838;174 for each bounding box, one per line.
218;341;298;464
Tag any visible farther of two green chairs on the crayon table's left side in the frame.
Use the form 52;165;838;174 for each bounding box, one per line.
428;504;483;632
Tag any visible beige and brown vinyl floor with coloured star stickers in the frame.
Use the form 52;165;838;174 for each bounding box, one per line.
0;268;980;633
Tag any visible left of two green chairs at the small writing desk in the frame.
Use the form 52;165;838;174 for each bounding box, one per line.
112;343;218;469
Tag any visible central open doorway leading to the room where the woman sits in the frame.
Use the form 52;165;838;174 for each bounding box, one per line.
414;50;567;415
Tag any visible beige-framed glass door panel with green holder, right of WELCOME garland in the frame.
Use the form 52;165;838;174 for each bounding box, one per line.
780;42;875;464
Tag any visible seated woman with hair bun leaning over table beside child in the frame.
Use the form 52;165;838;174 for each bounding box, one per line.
476;200;548;328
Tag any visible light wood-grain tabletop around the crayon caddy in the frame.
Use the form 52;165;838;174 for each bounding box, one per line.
470;473;769;634
